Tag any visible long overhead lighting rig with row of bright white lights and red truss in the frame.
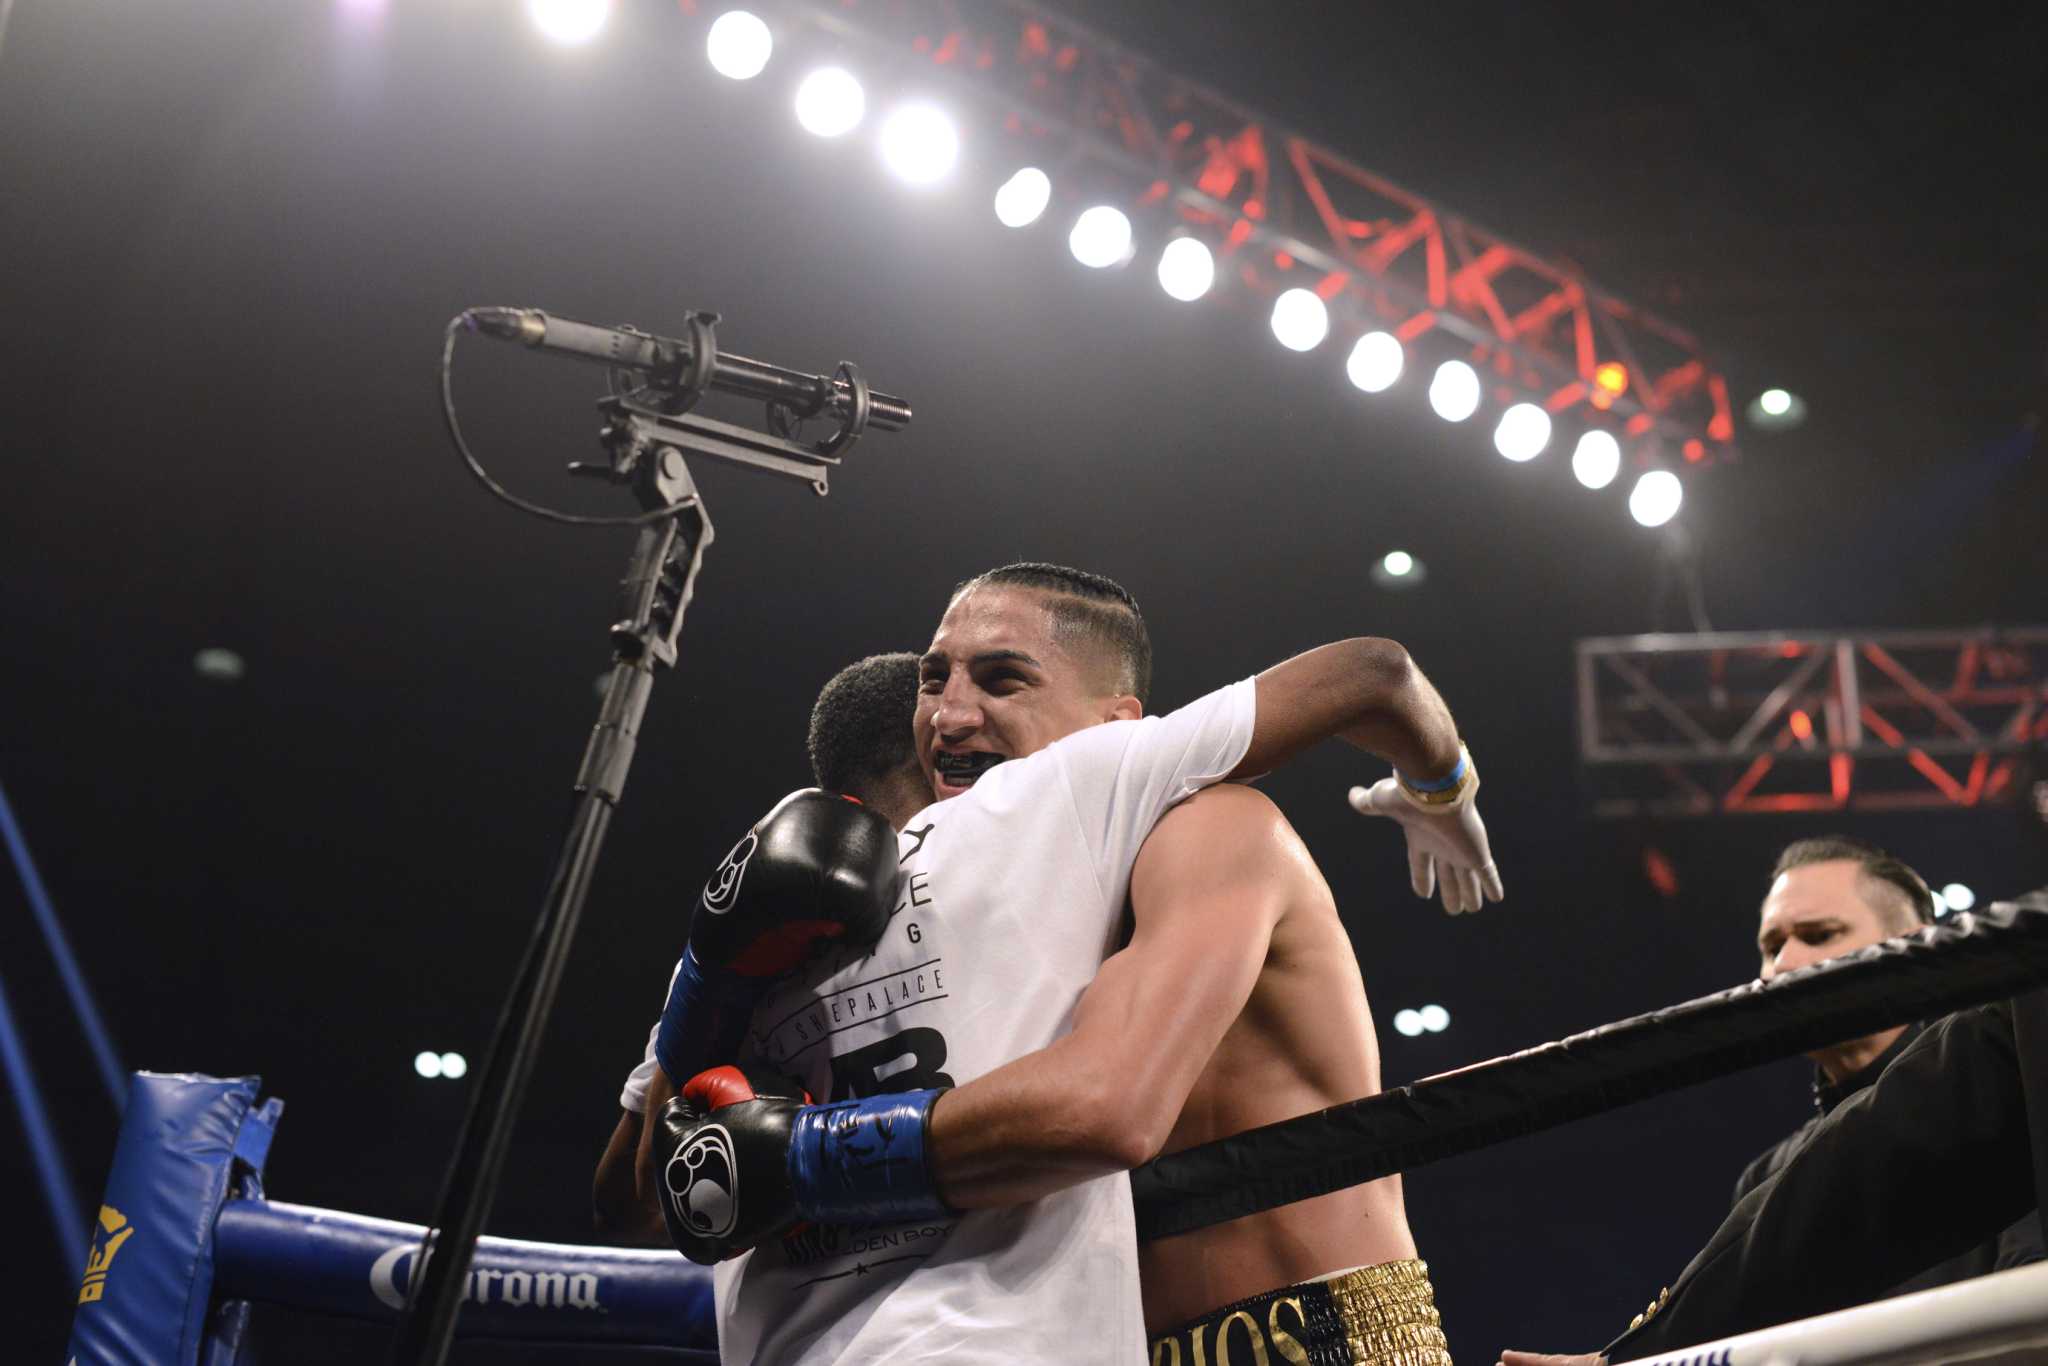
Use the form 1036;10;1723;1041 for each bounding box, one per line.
663;0;1736;526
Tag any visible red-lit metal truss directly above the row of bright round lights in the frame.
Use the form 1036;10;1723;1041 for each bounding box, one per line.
774;0;1735;461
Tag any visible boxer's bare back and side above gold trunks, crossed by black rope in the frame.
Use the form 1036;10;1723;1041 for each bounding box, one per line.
1139;797;1415;1331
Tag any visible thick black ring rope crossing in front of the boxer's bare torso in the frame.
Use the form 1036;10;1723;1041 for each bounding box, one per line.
1130;903;2048;1241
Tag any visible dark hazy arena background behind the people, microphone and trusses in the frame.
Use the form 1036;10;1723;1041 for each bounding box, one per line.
0;0;2048;1360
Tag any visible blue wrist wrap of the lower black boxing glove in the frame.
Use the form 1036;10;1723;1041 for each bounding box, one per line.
788;1090;952;1225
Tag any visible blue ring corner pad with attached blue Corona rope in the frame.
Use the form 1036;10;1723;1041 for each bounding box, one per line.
66;1071;719;1366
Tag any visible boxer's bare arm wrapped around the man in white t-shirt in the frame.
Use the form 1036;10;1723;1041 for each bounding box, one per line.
930;786;1300;1210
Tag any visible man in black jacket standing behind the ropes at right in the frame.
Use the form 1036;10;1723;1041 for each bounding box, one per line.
1503;840;2048;1366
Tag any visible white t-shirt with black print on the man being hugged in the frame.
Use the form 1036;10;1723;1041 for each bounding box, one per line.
629;680;1255;1366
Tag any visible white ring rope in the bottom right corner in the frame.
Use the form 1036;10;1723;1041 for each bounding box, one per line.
1614;1264;2048;1366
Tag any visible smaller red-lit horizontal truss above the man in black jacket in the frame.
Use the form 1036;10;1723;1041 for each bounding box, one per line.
1577;627;2048;817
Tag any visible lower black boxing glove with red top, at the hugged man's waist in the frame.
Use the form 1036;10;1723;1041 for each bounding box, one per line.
655;1065;811;1266
